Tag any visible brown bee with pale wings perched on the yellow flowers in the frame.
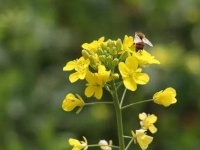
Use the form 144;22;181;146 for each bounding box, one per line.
134;32;153;52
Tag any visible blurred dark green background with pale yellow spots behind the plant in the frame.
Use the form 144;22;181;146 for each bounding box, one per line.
0;0;200;150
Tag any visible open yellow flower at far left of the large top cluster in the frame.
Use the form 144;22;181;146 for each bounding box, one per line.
63;57;90;83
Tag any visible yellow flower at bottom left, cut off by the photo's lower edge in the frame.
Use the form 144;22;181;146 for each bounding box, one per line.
69;137;88;150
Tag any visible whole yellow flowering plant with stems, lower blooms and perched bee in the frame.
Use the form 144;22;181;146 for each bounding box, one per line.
62;33;177;150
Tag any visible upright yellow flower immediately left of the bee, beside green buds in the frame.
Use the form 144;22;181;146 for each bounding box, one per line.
122;35;135;52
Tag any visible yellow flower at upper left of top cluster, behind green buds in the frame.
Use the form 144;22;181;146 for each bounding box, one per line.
82;37;104;52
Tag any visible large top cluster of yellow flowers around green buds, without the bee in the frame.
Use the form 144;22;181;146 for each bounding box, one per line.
63;35;160;99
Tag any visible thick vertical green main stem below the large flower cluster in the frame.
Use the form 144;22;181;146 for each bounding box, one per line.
111;80;125;150
